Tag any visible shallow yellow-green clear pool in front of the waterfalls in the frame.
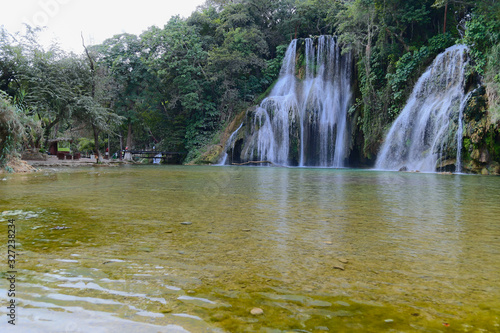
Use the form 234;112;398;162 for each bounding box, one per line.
0;166;500;333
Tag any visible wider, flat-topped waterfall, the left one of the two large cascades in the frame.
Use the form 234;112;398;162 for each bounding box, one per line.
225;36;351;167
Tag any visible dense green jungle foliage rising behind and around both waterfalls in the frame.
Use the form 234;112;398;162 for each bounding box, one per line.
0;0;500;163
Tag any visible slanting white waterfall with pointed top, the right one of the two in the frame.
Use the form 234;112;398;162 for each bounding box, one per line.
375;45;467;172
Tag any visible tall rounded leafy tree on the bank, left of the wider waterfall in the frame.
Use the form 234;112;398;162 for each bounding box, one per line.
141;17;218;158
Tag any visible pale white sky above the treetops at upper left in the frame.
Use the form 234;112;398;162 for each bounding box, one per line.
0;0;205;53
